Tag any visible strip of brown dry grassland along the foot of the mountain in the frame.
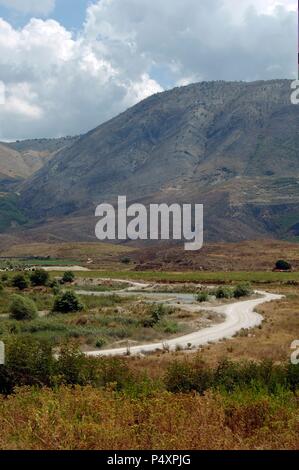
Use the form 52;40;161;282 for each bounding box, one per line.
0;241;299;271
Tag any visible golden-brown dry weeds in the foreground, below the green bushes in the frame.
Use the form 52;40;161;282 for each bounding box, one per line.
0;387;299;450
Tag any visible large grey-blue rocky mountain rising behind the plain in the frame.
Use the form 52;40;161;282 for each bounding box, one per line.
4;80;299;241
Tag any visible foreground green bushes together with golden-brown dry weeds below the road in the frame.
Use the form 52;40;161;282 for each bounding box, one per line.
0;337;299;450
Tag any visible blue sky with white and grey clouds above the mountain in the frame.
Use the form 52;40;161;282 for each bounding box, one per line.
0;0;297;141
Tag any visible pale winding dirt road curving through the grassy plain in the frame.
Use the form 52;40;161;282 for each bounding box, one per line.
77;281;283;356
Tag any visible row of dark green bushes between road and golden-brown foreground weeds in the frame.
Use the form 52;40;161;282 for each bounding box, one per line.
0;336;299;395
